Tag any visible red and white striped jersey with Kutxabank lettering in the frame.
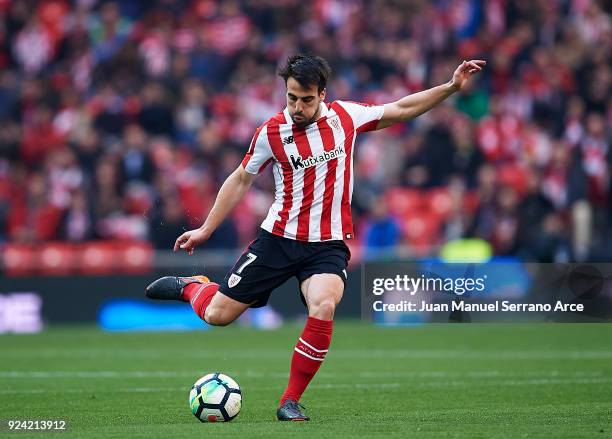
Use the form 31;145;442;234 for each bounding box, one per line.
242;101;384;242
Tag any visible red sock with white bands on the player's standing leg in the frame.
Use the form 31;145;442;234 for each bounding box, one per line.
280;317;334;404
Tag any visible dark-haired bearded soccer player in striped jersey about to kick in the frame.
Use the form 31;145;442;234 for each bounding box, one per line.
146;55;485;421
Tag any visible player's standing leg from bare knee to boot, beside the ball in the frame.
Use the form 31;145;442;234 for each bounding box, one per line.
277;273;344;421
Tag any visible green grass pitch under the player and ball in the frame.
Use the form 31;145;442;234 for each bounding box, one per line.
0;321;612;439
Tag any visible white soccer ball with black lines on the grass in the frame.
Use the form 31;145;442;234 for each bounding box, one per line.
189;373;242;422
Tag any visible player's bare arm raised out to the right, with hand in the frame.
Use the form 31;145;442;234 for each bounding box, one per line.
376;59;486;130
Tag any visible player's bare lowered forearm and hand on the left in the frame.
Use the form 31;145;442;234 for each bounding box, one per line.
174;165;255;255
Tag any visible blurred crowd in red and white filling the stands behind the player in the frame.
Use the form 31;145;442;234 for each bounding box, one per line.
0;0;612;261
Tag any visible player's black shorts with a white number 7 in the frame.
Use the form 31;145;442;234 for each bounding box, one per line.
219;229;351;308
